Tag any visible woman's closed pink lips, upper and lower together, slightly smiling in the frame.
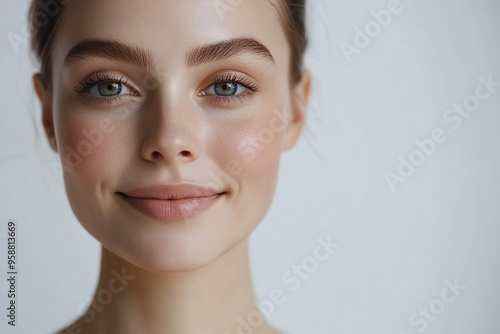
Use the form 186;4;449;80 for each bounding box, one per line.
118;183;224;222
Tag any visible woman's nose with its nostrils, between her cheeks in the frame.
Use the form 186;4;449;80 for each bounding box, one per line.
141;96;203;163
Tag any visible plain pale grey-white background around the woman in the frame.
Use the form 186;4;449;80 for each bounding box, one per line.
0;0;500;334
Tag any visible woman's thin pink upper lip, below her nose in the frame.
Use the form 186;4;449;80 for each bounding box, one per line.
120;182;222;200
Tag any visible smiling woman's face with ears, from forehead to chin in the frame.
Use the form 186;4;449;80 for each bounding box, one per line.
36;0;307;271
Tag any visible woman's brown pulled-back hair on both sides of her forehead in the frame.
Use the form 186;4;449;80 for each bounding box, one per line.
28;0;307;88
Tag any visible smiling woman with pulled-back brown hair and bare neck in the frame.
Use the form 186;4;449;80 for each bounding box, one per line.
29;0;311;334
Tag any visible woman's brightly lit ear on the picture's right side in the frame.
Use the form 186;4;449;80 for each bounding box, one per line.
282;69;312;152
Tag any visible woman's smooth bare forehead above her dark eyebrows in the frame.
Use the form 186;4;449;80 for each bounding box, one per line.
53;0;288;70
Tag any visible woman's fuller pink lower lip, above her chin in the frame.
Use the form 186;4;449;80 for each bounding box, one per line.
121;193;223;222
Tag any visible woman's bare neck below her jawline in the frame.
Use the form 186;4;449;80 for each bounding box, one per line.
68;239;275;334
